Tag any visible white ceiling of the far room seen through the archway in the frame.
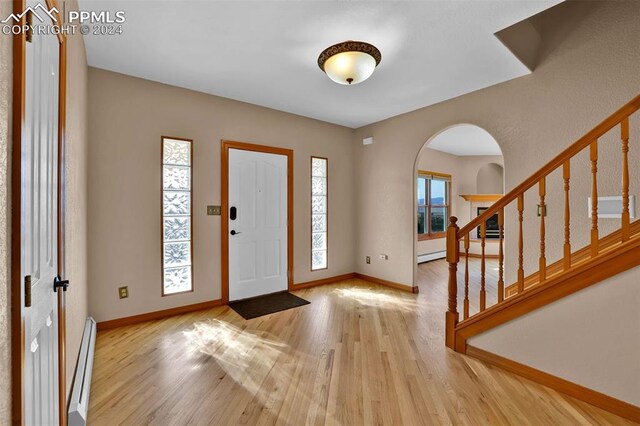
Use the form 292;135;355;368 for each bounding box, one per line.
427;124;502;156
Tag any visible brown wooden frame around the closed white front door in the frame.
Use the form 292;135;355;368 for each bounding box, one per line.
220;139;294;304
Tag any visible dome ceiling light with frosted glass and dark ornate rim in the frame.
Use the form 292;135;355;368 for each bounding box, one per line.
318;40;382;84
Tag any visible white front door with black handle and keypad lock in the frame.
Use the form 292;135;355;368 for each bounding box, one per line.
227;148;288;300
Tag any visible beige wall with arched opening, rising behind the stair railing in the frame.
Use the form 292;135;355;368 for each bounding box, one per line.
354;1;640;285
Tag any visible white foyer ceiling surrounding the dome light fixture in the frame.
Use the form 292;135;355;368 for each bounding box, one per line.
80;0;562;128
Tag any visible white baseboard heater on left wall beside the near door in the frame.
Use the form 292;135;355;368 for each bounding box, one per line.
69;317;96;426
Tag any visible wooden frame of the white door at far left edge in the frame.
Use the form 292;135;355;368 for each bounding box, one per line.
10;0;67;426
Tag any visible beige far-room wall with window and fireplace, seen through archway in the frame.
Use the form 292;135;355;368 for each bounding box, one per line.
417;146;503;256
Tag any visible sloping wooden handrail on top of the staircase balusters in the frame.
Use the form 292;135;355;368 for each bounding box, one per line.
457;95;640;240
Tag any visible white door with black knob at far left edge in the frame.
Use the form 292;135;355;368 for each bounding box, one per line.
21;2;59;425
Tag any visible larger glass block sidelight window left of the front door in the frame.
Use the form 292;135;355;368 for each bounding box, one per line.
162;137;193;296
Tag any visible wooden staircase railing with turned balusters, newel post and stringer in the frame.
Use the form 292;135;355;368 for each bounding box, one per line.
446;96;640;353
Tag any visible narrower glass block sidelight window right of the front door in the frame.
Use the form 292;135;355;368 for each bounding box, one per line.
311;157;328;271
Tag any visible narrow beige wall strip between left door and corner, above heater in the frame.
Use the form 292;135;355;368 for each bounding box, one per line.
65;0;89;392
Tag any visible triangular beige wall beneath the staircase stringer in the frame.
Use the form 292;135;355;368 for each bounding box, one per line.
469;268;640;406
